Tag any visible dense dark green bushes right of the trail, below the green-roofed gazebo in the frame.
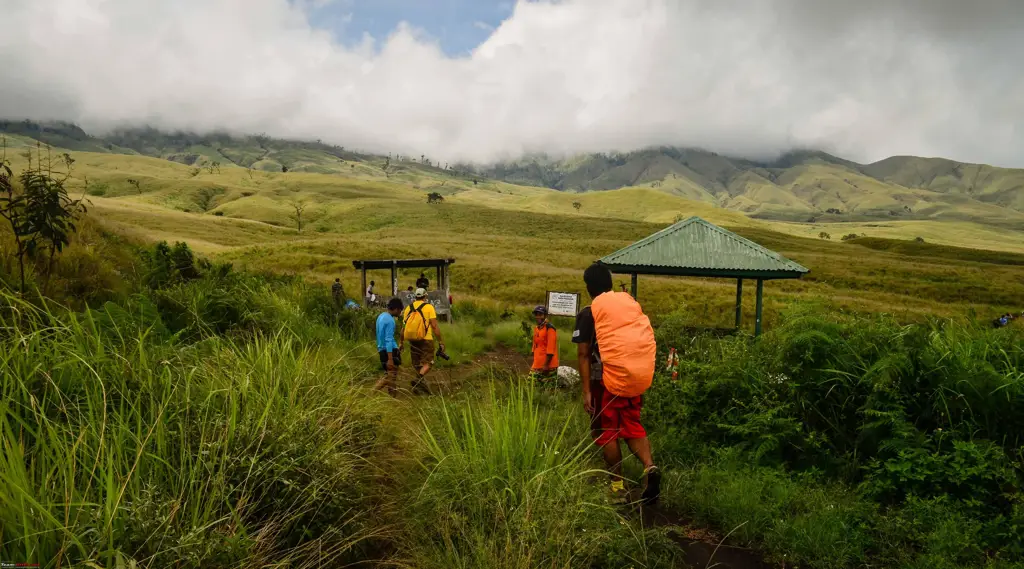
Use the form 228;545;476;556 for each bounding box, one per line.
647;311;1024;567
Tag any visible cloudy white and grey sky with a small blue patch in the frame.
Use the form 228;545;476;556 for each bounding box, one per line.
0;0;1024;167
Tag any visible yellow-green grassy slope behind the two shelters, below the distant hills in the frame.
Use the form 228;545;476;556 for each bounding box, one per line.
0;140;1024;325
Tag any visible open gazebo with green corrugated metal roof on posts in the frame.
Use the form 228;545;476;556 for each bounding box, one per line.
598;217;808;335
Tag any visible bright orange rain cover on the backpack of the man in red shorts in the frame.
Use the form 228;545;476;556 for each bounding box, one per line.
590;292;657;397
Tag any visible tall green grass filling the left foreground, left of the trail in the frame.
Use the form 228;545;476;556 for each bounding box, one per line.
0;295;384;567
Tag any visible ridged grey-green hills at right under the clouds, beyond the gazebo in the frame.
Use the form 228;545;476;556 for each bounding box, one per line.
471;148;1024;225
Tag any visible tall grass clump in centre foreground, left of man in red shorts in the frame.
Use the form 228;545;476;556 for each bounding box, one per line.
408;384;672;569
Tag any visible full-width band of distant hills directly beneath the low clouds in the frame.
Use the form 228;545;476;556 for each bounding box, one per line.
6;121;1024;229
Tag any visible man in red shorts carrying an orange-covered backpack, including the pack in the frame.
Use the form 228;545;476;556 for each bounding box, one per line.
573;264;662;504
